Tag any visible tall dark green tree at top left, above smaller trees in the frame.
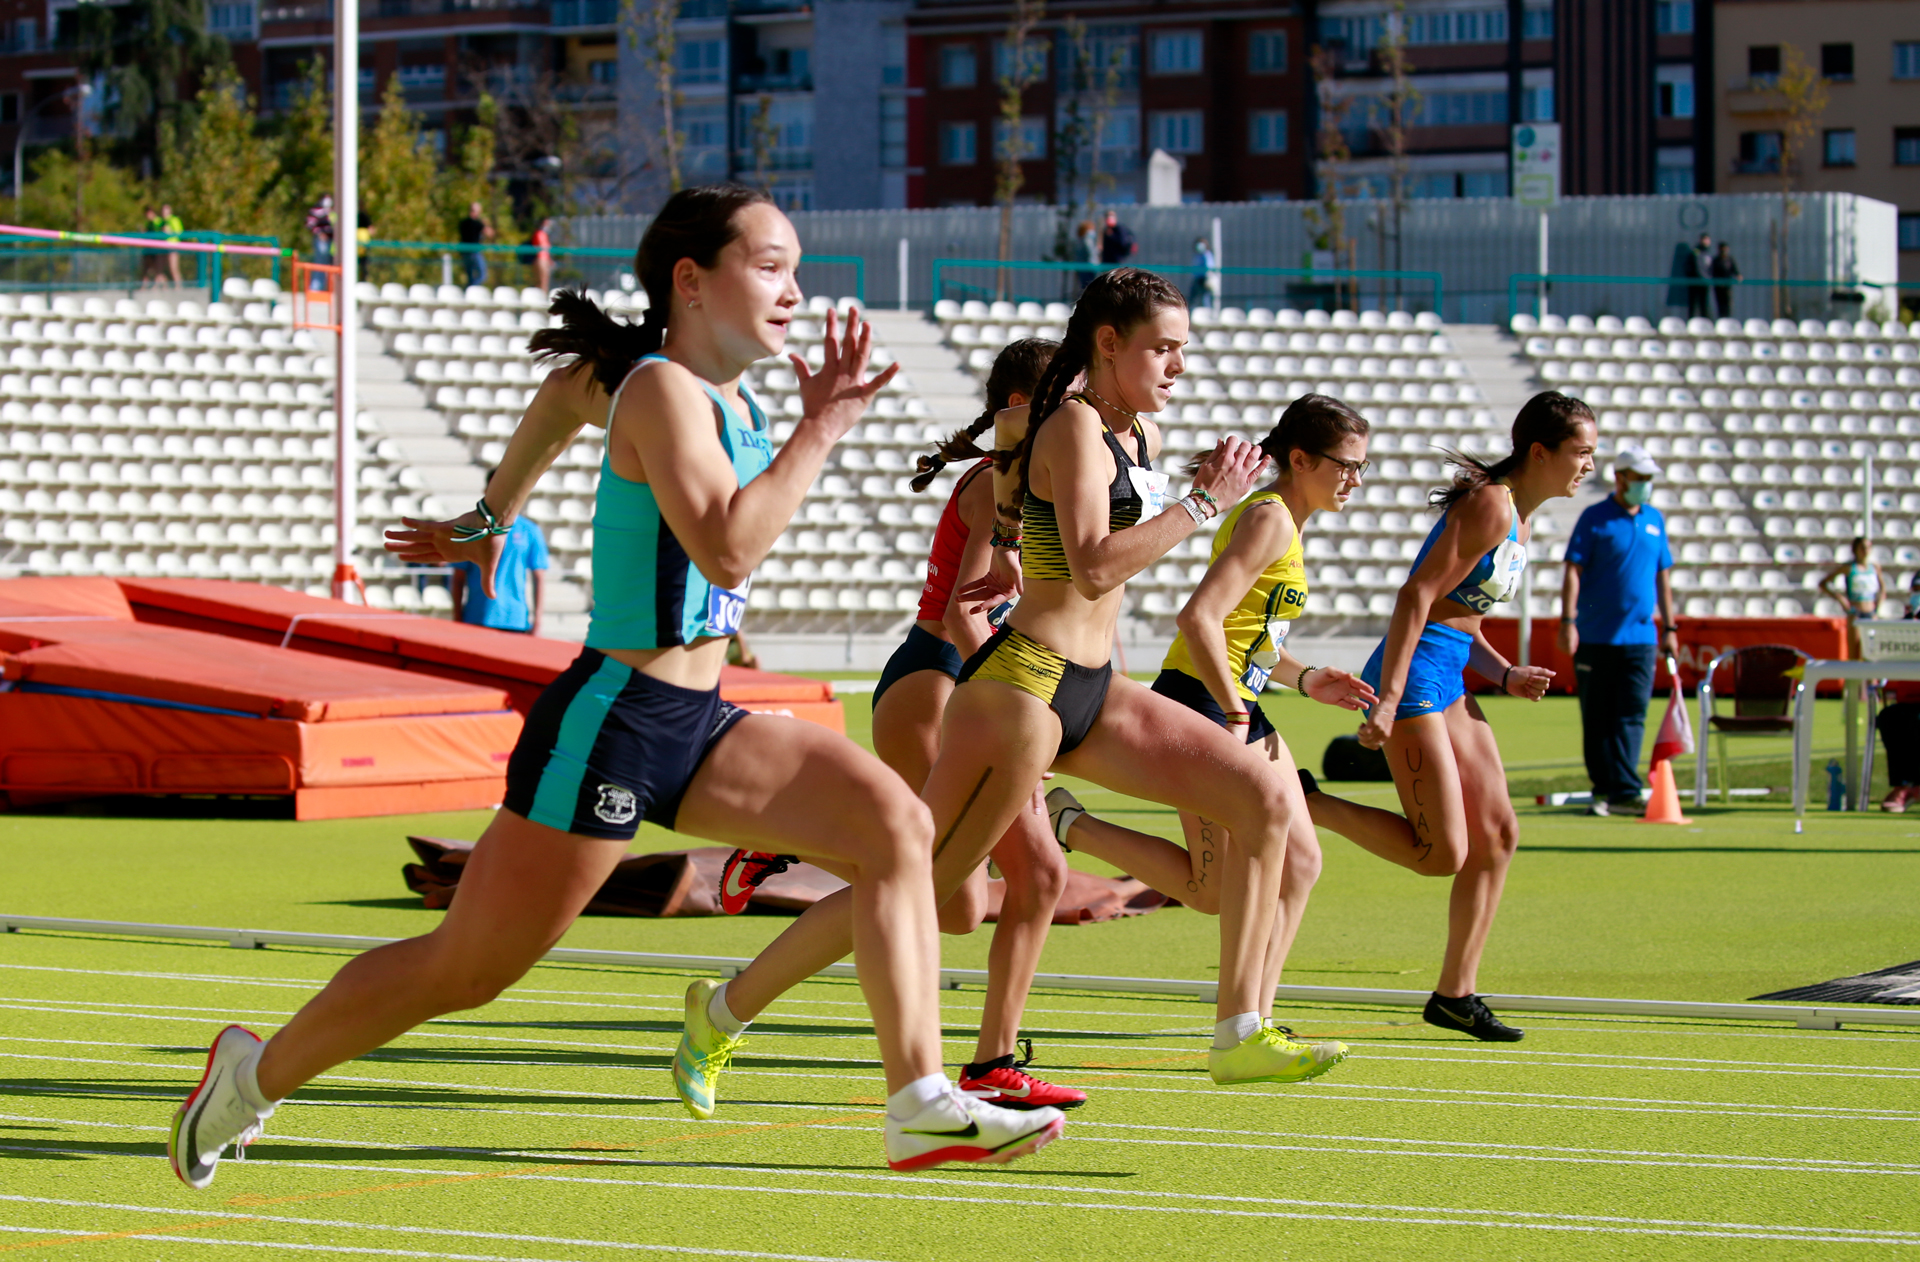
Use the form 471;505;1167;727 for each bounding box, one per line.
73;0;232;167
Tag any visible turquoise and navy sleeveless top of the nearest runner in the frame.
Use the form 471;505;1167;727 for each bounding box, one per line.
588;355;774;649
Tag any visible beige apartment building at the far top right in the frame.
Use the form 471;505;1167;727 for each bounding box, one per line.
1711;0;1920;282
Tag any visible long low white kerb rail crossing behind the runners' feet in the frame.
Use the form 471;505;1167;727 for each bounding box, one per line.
0;912;1920;1030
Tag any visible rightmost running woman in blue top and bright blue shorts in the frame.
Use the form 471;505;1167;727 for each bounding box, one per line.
1304;390;1599;1041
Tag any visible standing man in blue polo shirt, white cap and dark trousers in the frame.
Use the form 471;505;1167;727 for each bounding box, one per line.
1559;444;1680;814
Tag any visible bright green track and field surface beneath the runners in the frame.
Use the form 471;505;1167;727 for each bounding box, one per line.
0;697;1920;1262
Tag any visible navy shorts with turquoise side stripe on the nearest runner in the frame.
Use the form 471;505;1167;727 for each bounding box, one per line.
501;649;747;841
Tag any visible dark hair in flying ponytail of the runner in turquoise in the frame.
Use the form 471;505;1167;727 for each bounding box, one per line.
526;184;774;394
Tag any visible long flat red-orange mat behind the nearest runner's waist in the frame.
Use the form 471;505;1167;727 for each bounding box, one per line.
112;578;847;734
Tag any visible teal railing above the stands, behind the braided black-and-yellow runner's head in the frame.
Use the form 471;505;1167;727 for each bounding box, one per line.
933;259;1442;311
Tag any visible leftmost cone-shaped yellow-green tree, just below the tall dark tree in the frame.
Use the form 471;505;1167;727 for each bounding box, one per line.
157;65;280;234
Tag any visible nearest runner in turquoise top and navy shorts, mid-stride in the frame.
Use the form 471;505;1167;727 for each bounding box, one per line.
169;184;1062;1187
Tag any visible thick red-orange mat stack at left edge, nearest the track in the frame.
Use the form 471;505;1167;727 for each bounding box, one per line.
0;580;520;818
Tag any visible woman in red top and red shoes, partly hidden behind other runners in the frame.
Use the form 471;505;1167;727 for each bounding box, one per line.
716;338;1087;1108
